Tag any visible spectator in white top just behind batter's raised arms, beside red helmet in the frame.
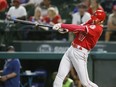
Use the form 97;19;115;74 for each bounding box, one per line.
72;3;91;24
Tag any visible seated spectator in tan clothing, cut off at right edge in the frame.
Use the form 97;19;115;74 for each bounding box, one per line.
105;5;116;41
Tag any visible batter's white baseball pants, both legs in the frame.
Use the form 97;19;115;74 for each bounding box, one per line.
53;46;98;87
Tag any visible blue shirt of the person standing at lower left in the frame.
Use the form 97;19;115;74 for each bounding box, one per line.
3;59;21;87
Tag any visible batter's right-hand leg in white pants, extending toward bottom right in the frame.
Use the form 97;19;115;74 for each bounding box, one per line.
71;51;98;87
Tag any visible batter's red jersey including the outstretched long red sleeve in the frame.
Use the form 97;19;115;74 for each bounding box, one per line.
61;24;103;50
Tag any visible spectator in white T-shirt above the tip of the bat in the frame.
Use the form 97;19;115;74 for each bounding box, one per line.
7;0;27;20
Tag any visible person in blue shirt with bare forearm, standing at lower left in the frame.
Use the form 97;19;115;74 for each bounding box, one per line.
0;46;21;87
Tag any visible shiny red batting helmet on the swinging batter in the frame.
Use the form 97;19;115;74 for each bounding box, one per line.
91;10;106;21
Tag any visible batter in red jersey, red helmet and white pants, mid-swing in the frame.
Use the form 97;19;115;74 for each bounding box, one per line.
53;10;106;87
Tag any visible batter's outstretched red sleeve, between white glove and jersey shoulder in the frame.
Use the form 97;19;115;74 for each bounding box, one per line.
61;24;88;32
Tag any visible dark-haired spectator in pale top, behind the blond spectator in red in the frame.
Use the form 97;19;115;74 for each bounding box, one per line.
40;0;59;16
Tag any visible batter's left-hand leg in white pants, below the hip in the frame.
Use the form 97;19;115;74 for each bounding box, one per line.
53;50;72;87
